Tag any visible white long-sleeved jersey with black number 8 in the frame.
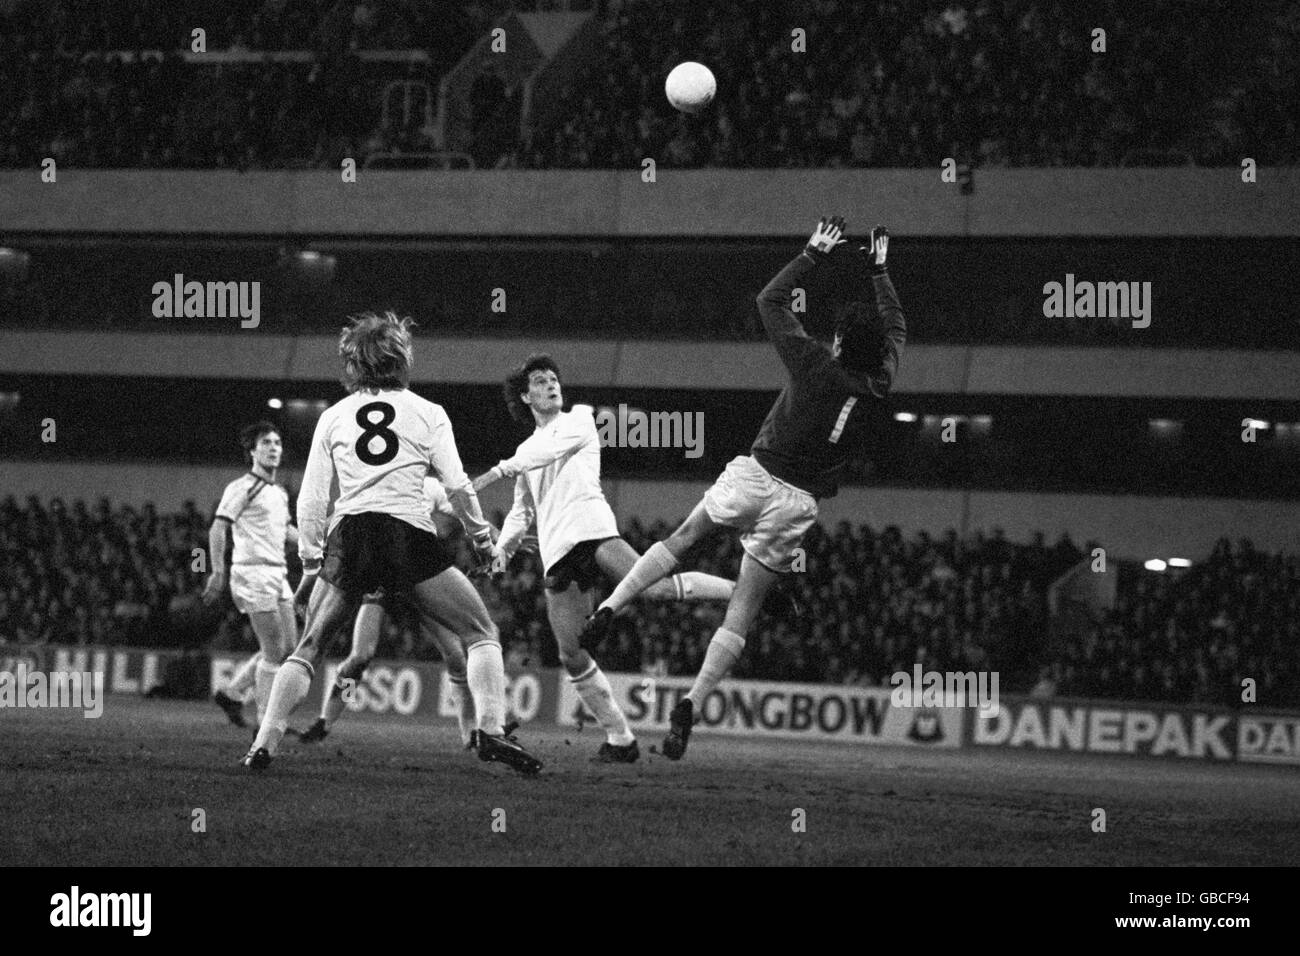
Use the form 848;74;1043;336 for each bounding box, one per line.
298;389;488;562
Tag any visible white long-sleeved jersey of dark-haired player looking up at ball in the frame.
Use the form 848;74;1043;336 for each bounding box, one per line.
497;405;619;571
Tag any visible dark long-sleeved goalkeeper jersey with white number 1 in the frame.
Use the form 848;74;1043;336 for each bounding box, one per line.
751;252;907;498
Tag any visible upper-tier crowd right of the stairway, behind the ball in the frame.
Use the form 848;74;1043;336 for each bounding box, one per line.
519;0;1300;168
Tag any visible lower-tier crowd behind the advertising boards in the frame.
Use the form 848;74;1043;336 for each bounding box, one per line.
0;497;1300;704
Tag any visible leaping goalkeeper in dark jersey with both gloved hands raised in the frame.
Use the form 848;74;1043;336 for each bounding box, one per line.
582;216;907;760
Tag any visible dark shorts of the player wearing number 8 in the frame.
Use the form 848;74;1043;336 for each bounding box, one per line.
321;512;455;597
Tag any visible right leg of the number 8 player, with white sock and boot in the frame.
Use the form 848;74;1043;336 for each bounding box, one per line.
412;567;542;774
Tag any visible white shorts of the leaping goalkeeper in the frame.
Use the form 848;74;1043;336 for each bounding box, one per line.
705;455;816;574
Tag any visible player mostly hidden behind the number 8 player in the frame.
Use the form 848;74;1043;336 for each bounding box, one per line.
300;477;476;749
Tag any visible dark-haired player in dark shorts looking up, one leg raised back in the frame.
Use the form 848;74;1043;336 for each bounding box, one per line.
475;355;736;763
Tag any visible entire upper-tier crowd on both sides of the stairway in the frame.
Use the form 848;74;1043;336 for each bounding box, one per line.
0;0;1300;168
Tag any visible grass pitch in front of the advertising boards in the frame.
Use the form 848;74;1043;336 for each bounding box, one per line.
0;697;1300;866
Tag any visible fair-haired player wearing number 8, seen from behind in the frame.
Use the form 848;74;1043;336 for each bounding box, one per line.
242;312;542;774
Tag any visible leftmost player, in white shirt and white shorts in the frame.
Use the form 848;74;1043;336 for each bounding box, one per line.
203;421;298;727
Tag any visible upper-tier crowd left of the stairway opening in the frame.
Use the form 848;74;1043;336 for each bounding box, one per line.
0;0;491;169
